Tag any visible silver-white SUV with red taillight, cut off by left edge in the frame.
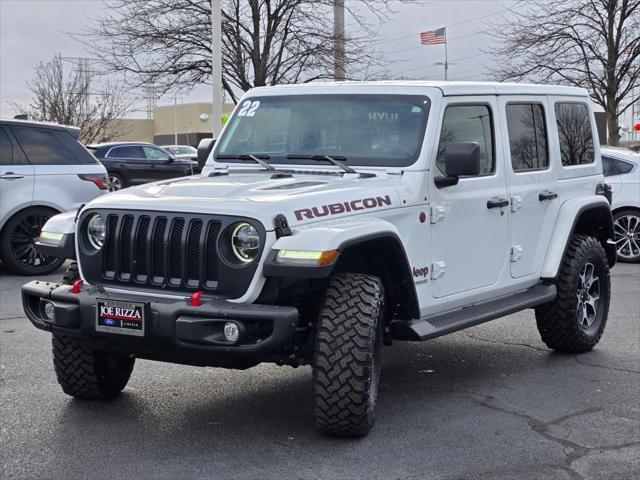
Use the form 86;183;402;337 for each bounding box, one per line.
0;120;108;275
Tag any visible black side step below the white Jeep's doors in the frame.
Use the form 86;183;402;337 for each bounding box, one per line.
391;284;556;342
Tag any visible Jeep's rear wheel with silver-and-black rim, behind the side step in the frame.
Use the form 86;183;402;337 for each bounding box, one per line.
536;235;611;353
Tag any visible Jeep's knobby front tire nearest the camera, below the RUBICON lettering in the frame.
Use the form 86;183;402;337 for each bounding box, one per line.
313;273;384;437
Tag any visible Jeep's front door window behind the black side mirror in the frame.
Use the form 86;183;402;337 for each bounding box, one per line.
436;105;495;175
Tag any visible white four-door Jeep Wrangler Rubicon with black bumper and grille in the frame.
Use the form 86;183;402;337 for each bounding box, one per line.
22;82;616;436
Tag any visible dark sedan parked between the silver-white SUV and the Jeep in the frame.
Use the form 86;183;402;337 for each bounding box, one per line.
87;142;198;191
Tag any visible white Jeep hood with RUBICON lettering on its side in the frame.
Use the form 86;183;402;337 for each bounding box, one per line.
86;171;402;230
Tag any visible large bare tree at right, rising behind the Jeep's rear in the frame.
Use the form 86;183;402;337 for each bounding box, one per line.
492;0;640;145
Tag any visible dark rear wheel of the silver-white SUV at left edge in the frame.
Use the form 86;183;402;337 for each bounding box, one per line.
0;207;65;275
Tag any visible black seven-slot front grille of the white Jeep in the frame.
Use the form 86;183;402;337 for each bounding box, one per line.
80;210;265;296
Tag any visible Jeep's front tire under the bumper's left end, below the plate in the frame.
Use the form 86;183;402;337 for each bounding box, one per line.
52;333;135;400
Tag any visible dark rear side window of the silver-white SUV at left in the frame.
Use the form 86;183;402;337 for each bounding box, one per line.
11;127;95;165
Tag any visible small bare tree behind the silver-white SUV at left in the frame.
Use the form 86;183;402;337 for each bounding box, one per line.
13;54;131;144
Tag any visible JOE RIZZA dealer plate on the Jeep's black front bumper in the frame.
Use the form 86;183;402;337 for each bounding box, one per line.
96;298;149;337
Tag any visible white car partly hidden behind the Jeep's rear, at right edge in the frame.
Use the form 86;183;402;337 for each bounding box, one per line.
602;147;640;263
